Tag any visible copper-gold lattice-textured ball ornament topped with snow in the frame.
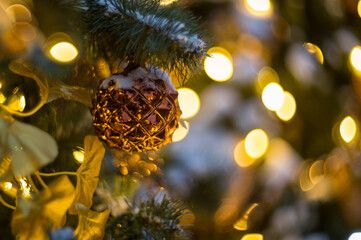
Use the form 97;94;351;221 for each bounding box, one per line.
91;67;182;152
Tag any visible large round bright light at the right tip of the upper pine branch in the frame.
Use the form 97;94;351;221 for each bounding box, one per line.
204;48;233;82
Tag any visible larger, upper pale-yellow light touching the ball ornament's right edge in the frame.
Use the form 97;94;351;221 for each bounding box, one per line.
178;88;200;118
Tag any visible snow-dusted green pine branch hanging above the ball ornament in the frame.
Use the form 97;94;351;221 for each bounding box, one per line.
83;0;206;84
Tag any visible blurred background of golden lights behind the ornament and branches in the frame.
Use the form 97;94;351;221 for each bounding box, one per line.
0;0;361;240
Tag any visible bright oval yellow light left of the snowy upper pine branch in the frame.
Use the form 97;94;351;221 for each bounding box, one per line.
50;42;78;63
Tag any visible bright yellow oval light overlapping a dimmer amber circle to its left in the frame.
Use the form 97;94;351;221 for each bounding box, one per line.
244;129;268;158
